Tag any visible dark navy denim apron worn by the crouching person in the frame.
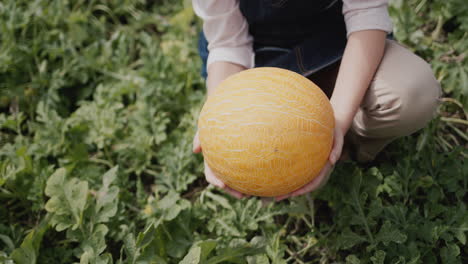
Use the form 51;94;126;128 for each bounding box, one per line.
199;0;347;78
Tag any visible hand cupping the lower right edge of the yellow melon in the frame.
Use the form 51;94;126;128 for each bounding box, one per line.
275;124;344;201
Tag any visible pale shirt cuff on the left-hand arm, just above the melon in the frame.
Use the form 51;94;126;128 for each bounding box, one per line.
207;46;255;69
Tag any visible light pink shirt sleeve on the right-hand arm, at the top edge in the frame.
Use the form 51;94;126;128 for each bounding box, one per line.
343;0;393;36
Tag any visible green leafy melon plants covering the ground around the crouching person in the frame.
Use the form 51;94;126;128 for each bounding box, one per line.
0;0;468;264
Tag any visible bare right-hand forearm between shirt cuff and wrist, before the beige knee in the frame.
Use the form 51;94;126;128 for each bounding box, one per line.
330;30;387;133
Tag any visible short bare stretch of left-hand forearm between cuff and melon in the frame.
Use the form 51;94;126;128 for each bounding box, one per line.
206;61;246;96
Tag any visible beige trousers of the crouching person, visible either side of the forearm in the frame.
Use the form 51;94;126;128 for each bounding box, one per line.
309;40;441;162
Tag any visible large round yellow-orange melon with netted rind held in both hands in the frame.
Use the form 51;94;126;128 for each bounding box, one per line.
198;67;335;197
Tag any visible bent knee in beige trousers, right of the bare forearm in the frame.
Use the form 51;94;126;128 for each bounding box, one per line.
360;42;442;136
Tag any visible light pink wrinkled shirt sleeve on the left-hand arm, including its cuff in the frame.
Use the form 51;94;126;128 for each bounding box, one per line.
192;0;254;68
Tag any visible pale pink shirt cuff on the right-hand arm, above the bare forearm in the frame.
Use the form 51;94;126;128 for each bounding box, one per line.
344;5;393;37
